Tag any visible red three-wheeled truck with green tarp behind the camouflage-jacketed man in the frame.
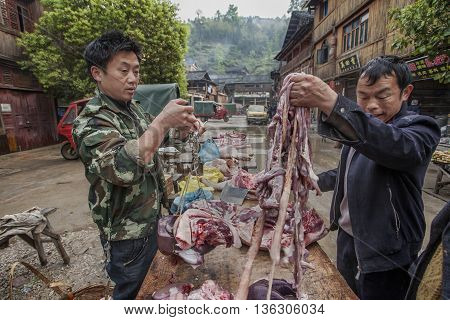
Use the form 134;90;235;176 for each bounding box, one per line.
57;83;180;160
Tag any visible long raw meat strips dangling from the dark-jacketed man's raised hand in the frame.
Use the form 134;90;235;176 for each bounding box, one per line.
237;74;326;299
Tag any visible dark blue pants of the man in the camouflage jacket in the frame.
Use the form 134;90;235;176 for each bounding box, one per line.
100;233;158;300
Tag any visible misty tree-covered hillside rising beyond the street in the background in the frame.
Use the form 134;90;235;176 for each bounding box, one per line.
186;5;288;74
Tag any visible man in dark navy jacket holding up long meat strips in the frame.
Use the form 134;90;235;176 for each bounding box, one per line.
290;56;440;299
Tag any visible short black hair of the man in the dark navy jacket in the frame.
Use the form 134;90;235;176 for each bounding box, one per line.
359;56;412;91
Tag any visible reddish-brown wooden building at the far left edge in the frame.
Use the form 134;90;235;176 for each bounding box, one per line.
0;0;57;154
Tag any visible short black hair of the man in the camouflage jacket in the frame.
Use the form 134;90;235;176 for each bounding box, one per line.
83;30;141;77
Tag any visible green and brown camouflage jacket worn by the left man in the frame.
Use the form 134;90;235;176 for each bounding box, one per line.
72;91;164;241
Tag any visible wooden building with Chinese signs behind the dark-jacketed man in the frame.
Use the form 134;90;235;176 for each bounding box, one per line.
288;0;450;115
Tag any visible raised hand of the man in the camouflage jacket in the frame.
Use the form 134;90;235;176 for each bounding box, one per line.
154;99;198;131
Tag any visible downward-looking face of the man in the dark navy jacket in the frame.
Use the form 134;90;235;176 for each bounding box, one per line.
356;73;413;122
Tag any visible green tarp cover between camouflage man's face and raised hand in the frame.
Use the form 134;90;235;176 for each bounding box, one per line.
133;83;180;117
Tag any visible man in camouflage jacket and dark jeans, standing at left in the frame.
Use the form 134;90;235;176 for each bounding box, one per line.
72;31;203;299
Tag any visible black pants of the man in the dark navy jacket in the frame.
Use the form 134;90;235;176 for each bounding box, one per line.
337;229;411;300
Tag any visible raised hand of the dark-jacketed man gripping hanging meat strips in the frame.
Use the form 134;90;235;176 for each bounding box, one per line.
289;74;337;115
